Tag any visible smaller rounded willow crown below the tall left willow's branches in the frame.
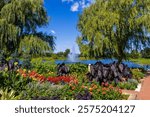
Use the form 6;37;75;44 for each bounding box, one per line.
18;33;54;56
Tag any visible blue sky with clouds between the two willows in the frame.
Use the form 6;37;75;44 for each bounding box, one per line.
41;0;93;53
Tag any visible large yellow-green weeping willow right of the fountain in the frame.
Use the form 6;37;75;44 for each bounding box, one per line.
77;0;150;61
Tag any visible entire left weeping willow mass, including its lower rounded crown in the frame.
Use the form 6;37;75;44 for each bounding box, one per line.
0;0;55;56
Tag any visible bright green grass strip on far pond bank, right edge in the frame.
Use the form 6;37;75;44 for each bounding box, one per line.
129;58;150;65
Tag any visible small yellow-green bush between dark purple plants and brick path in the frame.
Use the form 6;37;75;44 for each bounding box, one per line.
131;69;145;82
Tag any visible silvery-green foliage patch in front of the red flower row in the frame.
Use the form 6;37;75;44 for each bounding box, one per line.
20;82;61;100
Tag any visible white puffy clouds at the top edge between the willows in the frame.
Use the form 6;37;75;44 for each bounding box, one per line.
62;0;95;12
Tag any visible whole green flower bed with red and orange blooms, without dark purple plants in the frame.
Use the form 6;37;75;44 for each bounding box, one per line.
0;58;146;100
